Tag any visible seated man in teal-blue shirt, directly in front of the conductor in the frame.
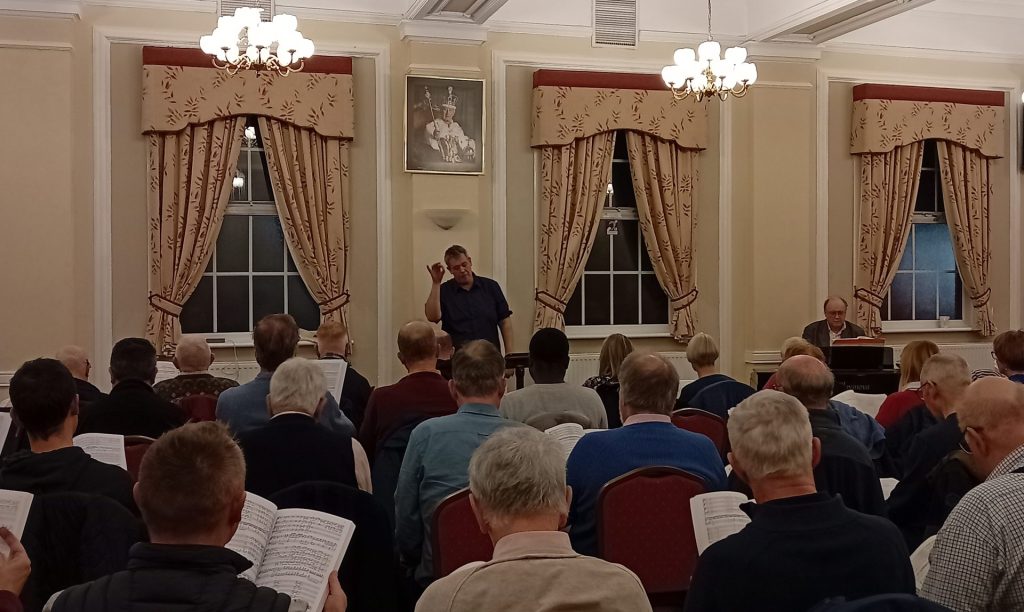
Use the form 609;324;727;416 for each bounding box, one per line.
394;340;524;586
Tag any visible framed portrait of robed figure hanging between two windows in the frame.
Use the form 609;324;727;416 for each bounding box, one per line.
406;75;485;174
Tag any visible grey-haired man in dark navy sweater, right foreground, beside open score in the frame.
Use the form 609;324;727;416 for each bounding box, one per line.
686;391;914;612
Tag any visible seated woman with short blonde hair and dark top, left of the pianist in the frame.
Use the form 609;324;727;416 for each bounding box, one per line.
676;333;754;419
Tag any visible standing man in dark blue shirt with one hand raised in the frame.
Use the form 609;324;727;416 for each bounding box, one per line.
423;245;514;354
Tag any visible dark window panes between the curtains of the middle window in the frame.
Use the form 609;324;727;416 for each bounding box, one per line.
565;131;669;334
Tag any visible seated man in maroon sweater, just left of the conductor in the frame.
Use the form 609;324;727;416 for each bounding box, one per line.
359;321;459;461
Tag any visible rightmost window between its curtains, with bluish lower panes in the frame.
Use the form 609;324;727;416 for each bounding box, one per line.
882;140;967;327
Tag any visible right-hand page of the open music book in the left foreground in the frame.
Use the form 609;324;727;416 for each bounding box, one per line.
256;510;355;611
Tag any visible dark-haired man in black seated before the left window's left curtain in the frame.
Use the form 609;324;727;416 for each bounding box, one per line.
78;338;187;438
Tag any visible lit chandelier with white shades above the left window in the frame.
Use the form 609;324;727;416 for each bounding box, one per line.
199;7;313;77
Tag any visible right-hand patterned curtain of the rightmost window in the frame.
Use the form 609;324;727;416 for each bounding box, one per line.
937;140;996;336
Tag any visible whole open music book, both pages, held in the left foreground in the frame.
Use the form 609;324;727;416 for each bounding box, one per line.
226;492;355;611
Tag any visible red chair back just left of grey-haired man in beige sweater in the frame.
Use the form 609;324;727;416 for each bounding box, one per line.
431;489;495;578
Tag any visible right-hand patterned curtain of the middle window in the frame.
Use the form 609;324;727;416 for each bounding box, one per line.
626;131;699;342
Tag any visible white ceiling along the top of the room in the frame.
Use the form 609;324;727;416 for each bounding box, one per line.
6;0;1024;60
